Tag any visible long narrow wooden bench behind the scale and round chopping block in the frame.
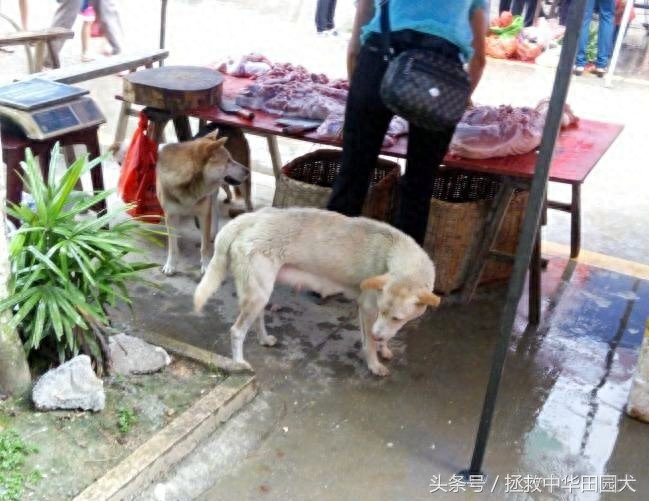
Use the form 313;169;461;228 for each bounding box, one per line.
24;49;169;143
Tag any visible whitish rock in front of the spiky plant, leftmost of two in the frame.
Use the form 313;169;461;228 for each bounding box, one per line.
32;355;106;411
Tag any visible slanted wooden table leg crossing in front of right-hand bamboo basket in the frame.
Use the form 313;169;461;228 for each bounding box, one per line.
461;179;514;303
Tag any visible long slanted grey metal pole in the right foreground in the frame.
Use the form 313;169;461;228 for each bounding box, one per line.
461;0;586;478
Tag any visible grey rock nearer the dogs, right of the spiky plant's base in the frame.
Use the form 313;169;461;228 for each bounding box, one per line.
108;333;171;374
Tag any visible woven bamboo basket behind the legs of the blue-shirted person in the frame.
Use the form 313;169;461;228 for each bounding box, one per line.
273;149;400;222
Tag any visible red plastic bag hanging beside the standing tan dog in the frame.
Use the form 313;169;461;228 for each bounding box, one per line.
117;113;164;223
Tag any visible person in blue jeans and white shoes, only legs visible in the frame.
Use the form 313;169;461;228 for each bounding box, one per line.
573;0;615;78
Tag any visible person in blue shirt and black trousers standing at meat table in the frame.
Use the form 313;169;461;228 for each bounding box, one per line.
327;0;487;244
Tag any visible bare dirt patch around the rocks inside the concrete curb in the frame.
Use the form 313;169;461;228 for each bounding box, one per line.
0;356;227;501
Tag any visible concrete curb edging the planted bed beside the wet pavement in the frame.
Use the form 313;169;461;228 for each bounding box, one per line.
73;334;258;501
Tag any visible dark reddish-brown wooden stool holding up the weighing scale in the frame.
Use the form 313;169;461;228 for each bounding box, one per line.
0;125;106;224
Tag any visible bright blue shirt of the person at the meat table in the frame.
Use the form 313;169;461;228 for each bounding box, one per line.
361;0;486;59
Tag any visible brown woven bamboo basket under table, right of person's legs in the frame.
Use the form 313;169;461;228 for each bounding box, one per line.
424;169;528;294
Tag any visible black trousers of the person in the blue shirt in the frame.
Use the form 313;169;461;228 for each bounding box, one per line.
327;30;461;244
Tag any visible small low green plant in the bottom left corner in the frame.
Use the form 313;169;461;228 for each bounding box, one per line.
0;430;41;501
